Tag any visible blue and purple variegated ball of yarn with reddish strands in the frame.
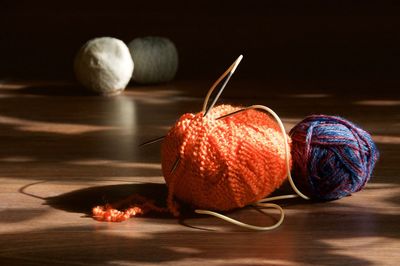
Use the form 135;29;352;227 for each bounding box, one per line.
290;115;379;201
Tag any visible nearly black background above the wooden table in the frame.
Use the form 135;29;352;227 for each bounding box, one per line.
0;0;400;84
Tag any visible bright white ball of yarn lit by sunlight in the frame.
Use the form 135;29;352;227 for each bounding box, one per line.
74;37;133;95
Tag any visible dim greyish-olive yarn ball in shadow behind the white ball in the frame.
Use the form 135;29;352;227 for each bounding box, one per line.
128;36;178;84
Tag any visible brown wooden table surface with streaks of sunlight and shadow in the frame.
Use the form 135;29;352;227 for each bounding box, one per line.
0;80;400;265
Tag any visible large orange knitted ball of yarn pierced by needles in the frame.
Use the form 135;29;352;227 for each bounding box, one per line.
161;105;289;211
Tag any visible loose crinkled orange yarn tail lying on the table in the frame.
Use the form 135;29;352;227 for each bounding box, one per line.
92;194;169;222
